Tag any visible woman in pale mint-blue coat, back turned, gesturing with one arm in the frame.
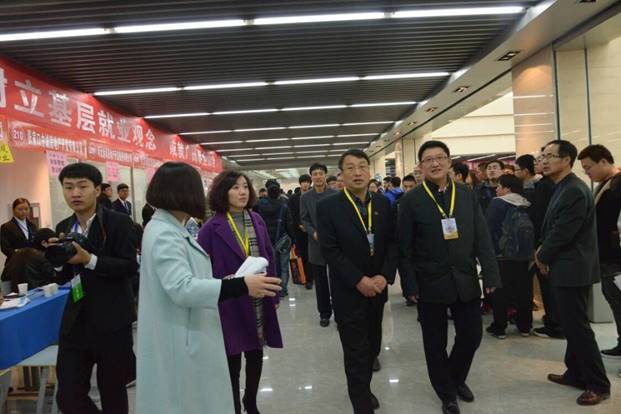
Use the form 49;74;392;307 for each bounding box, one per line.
136;162;280;414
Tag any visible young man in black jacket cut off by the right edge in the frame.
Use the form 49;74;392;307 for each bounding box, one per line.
578;144;621;364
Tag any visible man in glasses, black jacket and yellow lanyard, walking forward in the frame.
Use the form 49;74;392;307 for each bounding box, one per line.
399;141;501;413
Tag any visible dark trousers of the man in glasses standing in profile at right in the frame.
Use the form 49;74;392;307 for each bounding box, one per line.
552;286;610;393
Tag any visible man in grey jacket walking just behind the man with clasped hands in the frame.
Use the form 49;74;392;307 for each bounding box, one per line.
300;163;336;327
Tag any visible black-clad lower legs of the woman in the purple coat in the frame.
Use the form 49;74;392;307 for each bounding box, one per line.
228;349;263;414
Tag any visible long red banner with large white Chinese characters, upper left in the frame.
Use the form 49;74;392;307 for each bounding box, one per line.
0;59;222;172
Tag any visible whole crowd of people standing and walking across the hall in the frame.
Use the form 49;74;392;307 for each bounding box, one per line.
0;140;621;414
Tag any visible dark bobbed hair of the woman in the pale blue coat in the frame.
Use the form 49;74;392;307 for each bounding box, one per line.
147;162;205;219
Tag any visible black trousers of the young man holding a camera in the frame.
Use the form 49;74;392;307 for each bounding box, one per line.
56;319;136;414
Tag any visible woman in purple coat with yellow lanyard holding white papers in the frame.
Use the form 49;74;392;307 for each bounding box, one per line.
198;171;282;414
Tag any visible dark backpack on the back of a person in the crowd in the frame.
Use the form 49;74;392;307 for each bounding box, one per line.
498;206;535;261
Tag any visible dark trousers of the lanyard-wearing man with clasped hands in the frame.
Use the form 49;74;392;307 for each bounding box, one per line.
336;299;384;414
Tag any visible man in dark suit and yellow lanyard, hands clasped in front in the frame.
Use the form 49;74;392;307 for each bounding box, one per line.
317;149;398;414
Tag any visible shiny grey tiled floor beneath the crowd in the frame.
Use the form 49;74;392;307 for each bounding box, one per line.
9;280;621;414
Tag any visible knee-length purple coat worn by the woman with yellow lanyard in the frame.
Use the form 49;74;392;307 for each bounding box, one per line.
198;212;282;356
